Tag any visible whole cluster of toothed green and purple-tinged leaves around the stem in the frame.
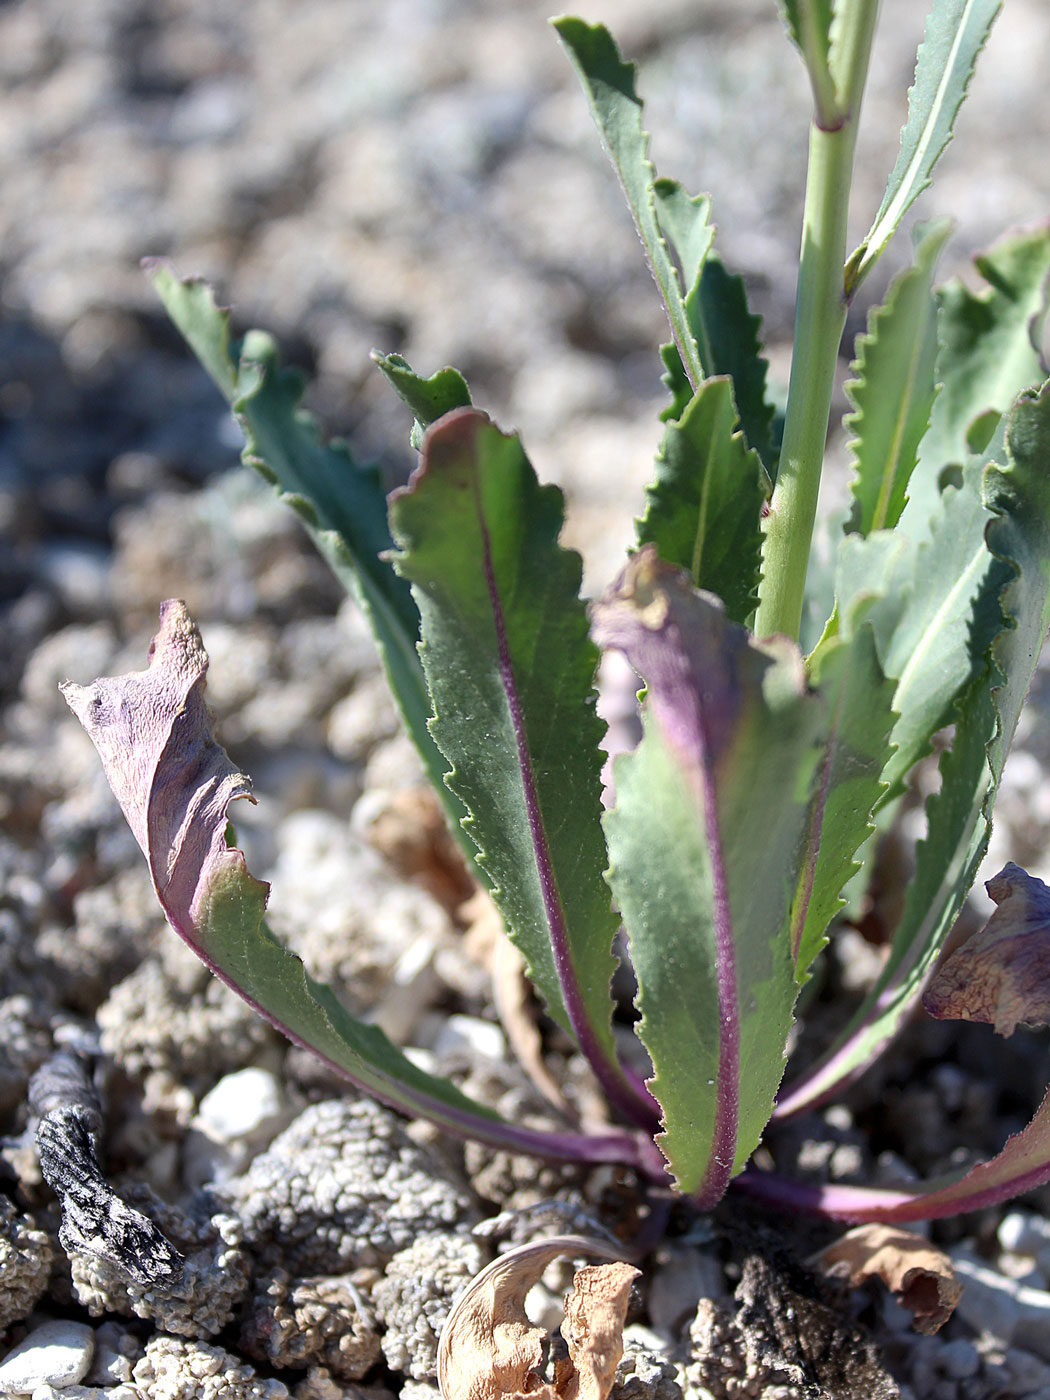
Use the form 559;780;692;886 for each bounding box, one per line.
67;0;1050;1221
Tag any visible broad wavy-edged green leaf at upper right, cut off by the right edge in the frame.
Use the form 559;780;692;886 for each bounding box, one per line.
902;225;1050;533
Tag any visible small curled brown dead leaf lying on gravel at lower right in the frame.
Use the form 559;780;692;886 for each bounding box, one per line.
813;1225;962;1333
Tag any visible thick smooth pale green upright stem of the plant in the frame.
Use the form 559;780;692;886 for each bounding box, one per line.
755;0;878;640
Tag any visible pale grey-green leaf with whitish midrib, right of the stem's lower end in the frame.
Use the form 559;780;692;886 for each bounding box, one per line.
816;468;1009;801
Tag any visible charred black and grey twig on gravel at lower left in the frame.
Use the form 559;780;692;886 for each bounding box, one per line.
29;1050;183;1284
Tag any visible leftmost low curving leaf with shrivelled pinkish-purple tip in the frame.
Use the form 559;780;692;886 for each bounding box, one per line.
63;601;649;1161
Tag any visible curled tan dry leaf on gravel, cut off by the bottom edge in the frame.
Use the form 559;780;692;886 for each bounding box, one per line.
438;1235;638;1400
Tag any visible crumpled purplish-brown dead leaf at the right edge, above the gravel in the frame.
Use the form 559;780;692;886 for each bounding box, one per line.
923;861;1050;1036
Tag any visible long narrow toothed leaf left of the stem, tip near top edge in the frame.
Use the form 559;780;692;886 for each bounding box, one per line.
552;15;713;388
